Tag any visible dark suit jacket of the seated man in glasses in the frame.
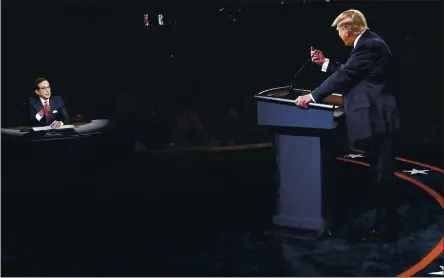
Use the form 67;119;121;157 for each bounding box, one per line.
28;96;69;126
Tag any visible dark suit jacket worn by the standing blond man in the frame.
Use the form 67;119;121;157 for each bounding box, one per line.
312;30;400;142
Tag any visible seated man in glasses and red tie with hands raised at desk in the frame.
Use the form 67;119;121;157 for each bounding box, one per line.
28;78;69;128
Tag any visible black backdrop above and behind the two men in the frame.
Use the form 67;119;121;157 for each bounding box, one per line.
2;0;444;156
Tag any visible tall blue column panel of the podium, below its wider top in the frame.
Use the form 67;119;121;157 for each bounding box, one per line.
273;134;324;231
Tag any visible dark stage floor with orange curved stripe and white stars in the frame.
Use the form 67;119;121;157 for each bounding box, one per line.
2;142;444;277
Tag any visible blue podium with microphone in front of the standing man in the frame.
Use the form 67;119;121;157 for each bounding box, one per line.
254;87;343;237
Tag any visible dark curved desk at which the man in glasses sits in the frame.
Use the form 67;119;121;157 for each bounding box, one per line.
1;119;114;187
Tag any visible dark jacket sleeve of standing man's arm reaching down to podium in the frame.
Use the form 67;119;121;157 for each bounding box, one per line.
311;42;379;102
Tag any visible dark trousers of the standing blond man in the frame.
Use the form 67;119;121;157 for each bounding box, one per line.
354;136;398;229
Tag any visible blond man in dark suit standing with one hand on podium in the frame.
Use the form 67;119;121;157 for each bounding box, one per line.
296;10;400;242
